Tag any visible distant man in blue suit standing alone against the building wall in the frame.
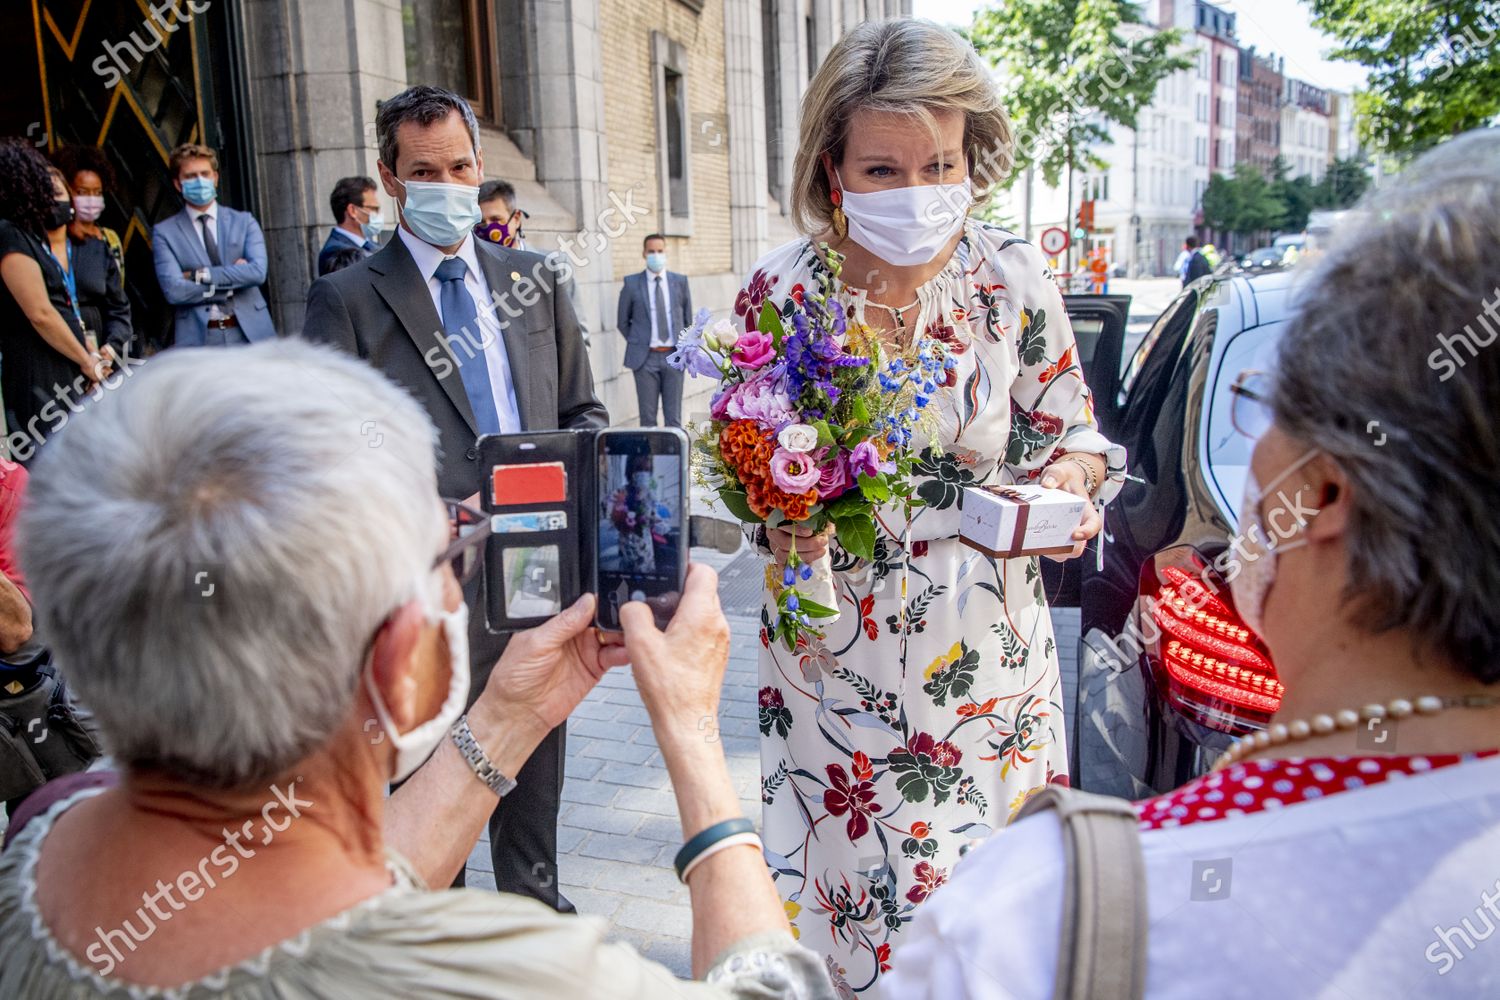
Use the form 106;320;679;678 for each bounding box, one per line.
615;232;693;427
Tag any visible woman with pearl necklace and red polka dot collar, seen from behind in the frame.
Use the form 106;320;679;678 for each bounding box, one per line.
882;129;1500;1000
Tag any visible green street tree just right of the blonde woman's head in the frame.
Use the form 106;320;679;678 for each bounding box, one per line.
968;0;1193;188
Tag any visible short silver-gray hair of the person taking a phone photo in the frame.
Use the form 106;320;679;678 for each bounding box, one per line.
18;340;447;789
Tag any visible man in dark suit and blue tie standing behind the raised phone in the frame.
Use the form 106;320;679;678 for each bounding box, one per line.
303;87;608;909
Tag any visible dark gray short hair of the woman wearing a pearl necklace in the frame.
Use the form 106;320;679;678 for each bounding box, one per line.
1272;129;1500;682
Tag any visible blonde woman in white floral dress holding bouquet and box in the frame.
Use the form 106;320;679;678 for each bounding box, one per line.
735;19;1124;993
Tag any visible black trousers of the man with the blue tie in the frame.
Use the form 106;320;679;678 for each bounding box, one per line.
450;580;575;913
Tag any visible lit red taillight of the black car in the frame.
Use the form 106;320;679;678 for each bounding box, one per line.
1149;565;1284;735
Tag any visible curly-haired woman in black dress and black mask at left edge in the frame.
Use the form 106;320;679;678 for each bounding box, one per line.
0;139;110;452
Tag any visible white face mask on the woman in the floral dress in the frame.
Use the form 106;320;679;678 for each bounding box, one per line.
834;171;974;267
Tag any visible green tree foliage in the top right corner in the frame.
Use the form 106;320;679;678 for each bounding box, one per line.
1307;0;1500;153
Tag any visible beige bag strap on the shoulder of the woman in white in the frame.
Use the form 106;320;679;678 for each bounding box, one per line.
1016;784;1146;1000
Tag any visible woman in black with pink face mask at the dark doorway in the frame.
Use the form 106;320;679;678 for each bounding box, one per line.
53;145;134;365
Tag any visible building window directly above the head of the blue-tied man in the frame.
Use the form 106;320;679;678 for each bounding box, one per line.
401;0;500;123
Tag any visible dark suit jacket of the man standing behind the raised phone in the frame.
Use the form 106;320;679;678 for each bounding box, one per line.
302;235;609;665
